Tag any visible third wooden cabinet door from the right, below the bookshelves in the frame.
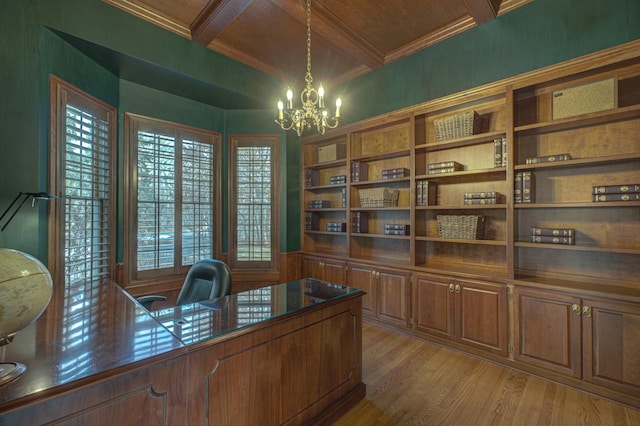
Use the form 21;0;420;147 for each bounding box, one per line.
454;280;507;355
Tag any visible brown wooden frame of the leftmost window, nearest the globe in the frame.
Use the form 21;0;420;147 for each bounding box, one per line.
48;75;117;298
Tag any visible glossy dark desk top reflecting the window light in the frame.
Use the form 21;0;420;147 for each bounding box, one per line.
0;279;362;416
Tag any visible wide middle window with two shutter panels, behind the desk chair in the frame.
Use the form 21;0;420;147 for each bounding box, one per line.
125;114;220;281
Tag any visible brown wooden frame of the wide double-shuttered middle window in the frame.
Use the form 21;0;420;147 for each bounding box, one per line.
123;112;222;286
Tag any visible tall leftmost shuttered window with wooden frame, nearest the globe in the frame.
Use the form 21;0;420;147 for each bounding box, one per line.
49;77;116;292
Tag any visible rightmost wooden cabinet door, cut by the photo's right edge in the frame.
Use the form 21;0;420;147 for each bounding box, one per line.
582;299;640;396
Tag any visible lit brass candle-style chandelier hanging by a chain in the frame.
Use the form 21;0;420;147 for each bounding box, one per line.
276;0;342;136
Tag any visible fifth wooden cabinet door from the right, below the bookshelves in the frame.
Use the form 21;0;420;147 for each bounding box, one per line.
376;269;410;327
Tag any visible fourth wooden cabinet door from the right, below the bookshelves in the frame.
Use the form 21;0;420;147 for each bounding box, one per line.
413;275;455;339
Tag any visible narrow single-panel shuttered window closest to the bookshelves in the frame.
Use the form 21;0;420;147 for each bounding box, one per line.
229;135;280;270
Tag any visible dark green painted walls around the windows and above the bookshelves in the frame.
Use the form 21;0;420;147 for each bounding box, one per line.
0;0;640;260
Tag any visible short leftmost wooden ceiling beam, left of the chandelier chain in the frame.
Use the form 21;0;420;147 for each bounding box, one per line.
191;0;253;46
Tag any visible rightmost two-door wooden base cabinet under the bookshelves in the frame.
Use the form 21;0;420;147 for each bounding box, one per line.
514;287;640;397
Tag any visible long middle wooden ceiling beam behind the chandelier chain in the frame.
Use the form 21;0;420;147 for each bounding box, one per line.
270;0;384;70
